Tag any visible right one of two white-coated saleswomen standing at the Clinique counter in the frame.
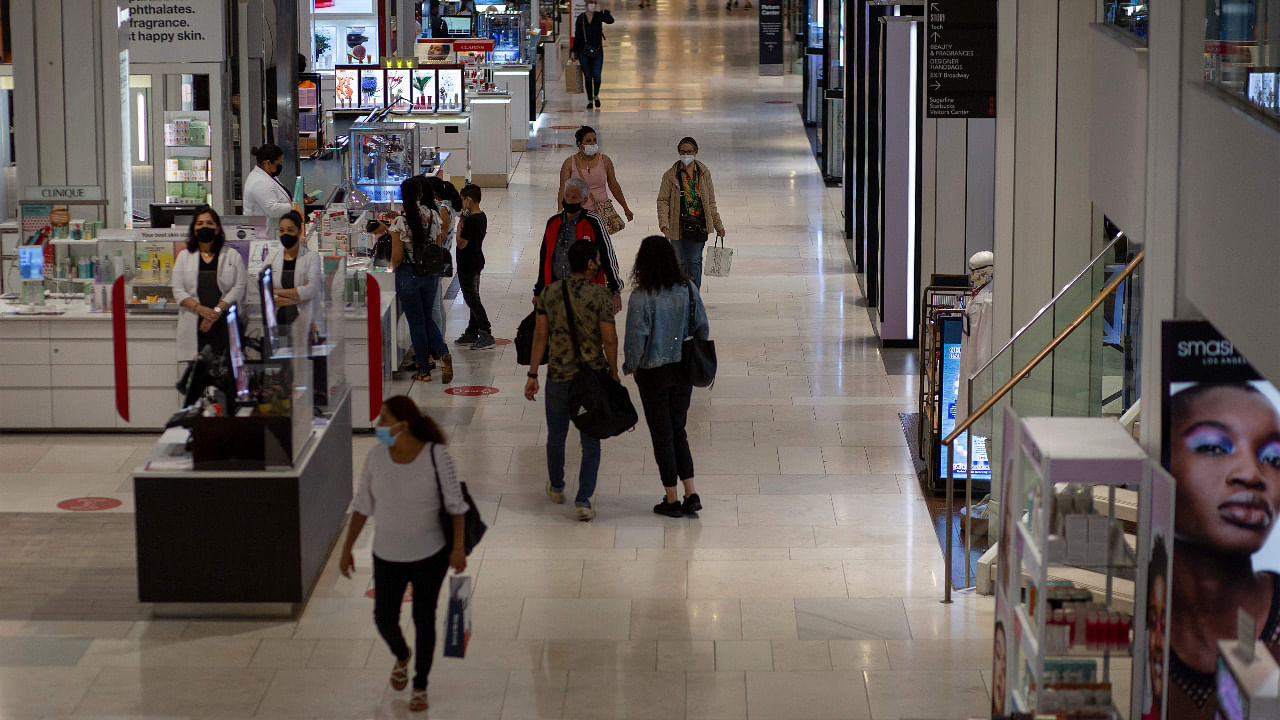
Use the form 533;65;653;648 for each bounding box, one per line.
266;210;324;340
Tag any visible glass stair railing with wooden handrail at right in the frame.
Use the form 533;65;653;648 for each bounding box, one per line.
942;234;1142;600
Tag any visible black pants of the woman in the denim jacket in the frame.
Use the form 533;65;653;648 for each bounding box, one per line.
636;363;694;488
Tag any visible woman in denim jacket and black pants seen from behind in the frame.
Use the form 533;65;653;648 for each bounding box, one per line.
622;236;710;518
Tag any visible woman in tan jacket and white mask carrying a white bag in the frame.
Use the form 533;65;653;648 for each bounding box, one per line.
658;137;724;290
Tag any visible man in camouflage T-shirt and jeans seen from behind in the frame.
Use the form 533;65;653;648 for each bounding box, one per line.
525;240;618;521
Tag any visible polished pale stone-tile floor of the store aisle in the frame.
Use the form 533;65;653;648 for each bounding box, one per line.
0;0;992;720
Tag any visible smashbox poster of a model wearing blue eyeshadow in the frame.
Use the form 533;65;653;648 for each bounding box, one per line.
1152;320;1280;717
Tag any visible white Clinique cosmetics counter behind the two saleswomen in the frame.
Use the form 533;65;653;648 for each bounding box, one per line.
0;229;399;432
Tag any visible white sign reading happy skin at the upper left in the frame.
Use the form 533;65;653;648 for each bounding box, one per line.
129;0;227;63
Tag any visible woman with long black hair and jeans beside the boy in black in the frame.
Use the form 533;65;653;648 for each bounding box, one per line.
390;177;453;384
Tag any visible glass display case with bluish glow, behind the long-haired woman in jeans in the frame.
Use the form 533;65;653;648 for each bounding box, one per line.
349;121;422;204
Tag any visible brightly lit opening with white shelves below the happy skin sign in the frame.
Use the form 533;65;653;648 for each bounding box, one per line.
129;63;228;222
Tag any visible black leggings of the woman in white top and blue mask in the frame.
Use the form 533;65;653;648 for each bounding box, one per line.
374;550;449;691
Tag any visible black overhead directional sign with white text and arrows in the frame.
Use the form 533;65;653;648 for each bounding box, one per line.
924;0;997;118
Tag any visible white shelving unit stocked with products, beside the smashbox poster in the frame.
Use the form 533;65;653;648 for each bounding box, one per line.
993;410;1174;720
